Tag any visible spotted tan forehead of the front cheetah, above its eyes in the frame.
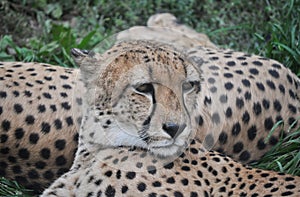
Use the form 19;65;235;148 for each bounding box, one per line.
79;40;199;87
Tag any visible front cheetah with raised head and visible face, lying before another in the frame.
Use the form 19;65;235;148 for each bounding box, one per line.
42;41;300;196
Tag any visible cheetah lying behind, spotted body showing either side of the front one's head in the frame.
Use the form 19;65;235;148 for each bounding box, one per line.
0;14;299;194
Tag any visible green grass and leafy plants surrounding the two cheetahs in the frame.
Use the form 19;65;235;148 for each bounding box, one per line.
0;0;300;196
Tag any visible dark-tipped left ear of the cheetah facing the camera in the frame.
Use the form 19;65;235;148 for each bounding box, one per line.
71;48;103;86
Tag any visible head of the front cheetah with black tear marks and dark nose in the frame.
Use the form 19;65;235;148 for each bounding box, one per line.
73;42;200;157
